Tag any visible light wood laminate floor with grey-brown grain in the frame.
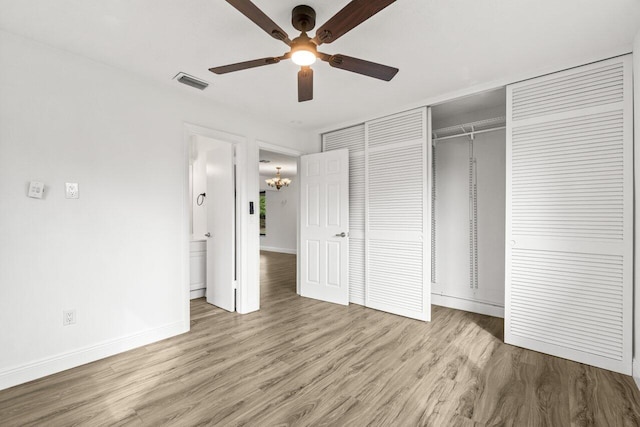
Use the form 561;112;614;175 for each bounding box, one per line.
0;252;640;427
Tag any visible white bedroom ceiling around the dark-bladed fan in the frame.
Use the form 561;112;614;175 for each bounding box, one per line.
0;0;640;130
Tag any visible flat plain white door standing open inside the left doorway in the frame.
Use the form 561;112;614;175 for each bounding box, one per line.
206;140;235;311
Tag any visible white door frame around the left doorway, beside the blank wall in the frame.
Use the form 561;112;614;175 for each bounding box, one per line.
182;122;250;324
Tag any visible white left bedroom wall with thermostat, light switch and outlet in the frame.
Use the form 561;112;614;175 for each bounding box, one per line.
0;32;319;389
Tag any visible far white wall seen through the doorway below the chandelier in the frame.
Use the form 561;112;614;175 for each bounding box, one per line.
260;176;298;254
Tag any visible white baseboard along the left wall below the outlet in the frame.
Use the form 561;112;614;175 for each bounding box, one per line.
0;321;189;390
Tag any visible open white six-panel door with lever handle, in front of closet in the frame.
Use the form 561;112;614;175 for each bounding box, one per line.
299;149;349;305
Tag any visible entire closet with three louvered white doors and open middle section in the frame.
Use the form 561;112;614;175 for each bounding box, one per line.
322;55;634;374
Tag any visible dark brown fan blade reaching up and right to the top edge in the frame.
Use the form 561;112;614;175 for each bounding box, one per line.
313;0;395;46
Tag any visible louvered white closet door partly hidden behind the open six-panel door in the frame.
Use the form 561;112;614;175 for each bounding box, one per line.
322;124;365;305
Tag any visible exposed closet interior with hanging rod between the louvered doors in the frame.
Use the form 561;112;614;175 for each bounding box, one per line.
431;89;506;317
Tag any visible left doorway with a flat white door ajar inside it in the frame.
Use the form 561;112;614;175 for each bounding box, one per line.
184;124;248;318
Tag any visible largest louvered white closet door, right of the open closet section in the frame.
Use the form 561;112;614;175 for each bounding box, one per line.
505;56;633;374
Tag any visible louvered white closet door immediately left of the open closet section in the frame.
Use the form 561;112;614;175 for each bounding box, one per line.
365;108;431;320
